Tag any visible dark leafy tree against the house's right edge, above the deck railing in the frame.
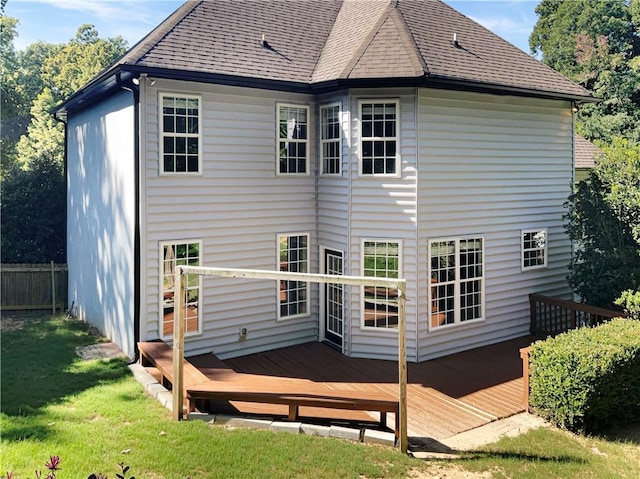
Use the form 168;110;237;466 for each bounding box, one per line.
566;138;640;307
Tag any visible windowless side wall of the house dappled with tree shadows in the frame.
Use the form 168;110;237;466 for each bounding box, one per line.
67;92;136;357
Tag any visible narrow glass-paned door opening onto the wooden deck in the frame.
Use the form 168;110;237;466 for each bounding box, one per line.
324;249;344;349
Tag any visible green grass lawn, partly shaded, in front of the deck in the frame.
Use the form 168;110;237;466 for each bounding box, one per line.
0;317;640;479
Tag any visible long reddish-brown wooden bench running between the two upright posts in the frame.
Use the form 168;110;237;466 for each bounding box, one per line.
187;380;400;439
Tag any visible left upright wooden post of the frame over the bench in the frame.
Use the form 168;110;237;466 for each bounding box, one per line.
172;266;185;421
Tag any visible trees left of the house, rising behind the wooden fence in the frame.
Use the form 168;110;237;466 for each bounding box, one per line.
0;20;127;262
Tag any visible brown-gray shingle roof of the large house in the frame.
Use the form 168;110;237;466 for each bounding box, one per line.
57;0;592;111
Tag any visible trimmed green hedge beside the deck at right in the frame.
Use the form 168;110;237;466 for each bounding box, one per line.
529;318;640;433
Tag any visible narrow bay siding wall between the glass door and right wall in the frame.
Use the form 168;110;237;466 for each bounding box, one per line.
346;89;418;361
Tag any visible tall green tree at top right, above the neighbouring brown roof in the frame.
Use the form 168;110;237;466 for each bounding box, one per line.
529;0;640;143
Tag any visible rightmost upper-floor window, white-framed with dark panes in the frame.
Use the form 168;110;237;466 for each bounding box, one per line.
360;100;400;176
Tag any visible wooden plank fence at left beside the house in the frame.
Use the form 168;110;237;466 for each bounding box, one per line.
0;262;68;314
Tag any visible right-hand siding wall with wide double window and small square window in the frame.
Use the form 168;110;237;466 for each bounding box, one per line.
418;89;573;360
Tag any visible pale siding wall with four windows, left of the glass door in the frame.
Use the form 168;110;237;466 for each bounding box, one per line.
141;80;318;358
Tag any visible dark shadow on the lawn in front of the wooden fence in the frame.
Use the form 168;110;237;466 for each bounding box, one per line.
0;317;129;422
